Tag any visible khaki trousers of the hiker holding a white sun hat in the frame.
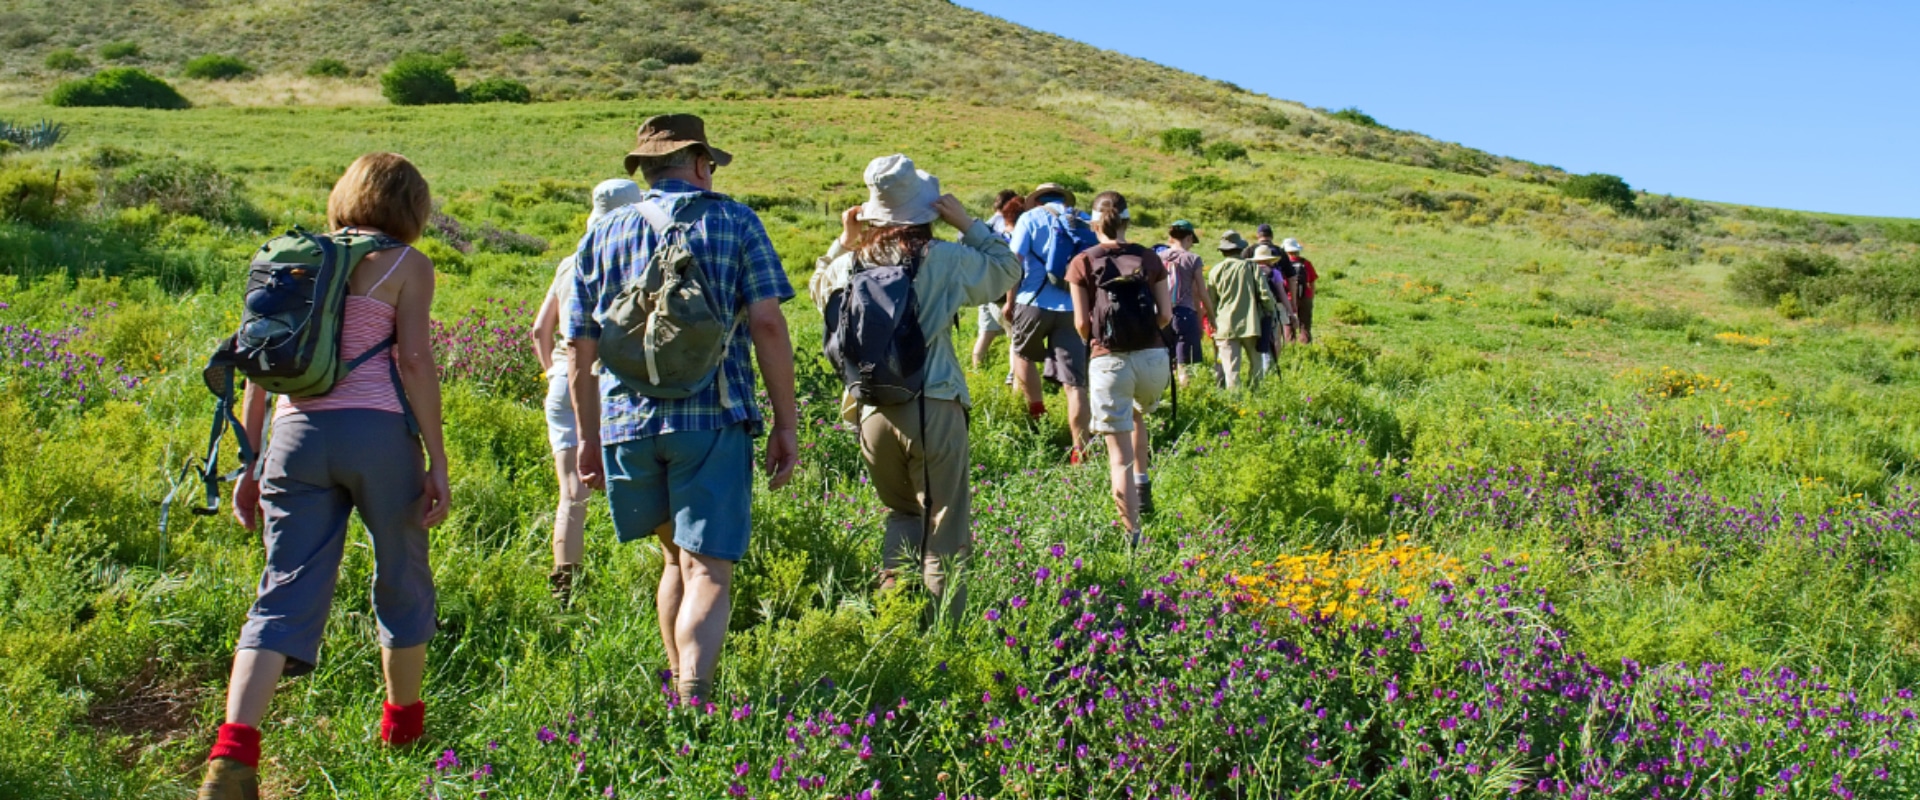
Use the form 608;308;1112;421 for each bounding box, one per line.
860;399;973;620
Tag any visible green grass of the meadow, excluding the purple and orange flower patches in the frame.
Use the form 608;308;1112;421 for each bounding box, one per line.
0;96;1920;798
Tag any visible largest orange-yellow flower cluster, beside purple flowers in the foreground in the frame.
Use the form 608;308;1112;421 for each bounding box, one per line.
1227;533;1461;622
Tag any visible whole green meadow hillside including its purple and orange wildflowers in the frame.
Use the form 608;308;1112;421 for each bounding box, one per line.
0;96;1920;800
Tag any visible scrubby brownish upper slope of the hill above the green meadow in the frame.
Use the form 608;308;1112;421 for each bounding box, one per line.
0;0;1557;178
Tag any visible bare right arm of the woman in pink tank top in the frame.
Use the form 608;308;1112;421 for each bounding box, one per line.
394;251;453;528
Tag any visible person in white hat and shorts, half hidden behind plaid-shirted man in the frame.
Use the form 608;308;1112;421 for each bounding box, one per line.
534;178;641;604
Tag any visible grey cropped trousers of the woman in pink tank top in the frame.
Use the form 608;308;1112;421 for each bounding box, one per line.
238;409;438;675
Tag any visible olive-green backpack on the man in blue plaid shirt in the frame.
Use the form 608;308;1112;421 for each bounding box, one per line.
599;196;741;407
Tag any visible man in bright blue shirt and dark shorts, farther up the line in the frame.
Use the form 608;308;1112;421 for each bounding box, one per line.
1006;184;1098;464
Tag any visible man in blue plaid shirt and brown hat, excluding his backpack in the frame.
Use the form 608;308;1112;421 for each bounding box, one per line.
563;115;799;702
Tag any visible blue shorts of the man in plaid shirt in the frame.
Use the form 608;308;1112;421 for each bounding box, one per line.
605;422;753;560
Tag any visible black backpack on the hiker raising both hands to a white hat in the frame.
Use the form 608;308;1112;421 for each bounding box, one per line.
826;255;927;405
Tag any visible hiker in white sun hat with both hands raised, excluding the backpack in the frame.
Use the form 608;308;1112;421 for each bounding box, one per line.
810;155;1020;614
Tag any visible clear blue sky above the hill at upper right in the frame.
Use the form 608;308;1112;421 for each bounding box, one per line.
956;0;1920;217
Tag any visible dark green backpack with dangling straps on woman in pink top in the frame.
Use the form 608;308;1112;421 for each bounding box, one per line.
194;228;413;516
